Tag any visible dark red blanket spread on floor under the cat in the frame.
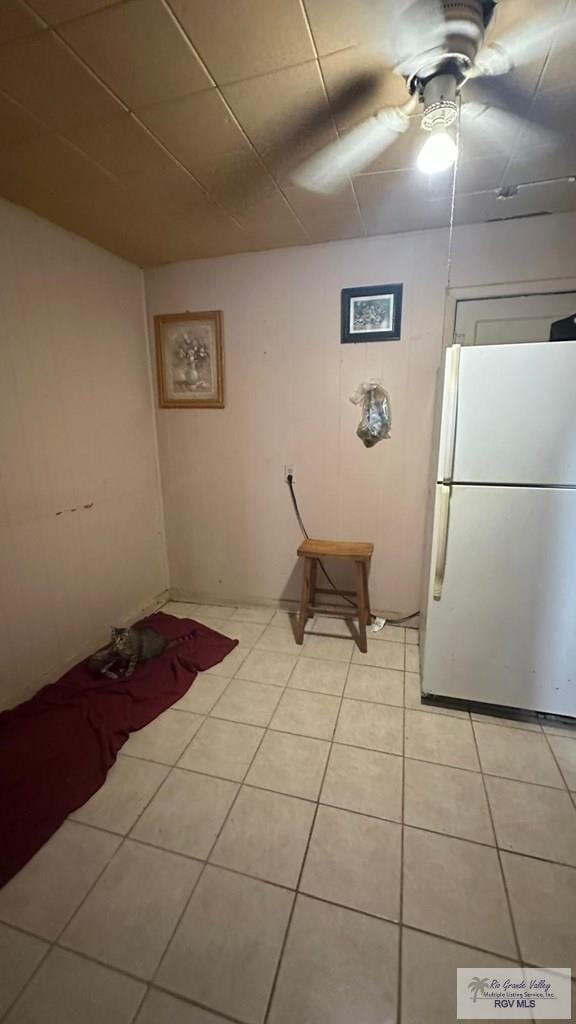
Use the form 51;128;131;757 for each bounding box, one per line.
0;612;238;886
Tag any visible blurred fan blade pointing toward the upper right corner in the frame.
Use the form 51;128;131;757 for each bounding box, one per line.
476;8;576;75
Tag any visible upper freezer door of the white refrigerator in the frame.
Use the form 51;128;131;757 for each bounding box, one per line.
452;341;576;486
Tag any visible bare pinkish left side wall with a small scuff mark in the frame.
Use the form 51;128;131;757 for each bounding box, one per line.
0;201;166;708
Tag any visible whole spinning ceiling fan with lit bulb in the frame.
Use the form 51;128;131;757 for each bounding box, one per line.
291;0;576;193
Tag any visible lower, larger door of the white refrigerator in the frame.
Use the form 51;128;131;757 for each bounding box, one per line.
422;485;576;717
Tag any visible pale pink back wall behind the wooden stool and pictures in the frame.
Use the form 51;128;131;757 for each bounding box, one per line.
146;209;576;613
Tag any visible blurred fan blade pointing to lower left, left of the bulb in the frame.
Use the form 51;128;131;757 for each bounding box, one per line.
291;97;418;193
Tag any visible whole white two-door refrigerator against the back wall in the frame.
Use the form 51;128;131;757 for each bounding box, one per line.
421;342;576;717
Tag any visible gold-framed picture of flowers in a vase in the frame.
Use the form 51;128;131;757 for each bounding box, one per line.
154;309;224;409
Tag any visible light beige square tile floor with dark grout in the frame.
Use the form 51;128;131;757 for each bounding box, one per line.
0;604;576;1024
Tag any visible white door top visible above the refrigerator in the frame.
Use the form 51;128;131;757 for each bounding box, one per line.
454;292;576;345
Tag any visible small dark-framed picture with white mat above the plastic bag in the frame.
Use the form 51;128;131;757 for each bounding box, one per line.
340;285;402;343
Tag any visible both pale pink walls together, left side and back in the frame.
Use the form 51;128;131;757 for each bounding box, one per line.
0;201;576;708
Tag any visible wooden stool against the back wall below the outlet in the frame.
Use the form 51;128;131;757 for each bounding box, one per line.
296;540;374;652
